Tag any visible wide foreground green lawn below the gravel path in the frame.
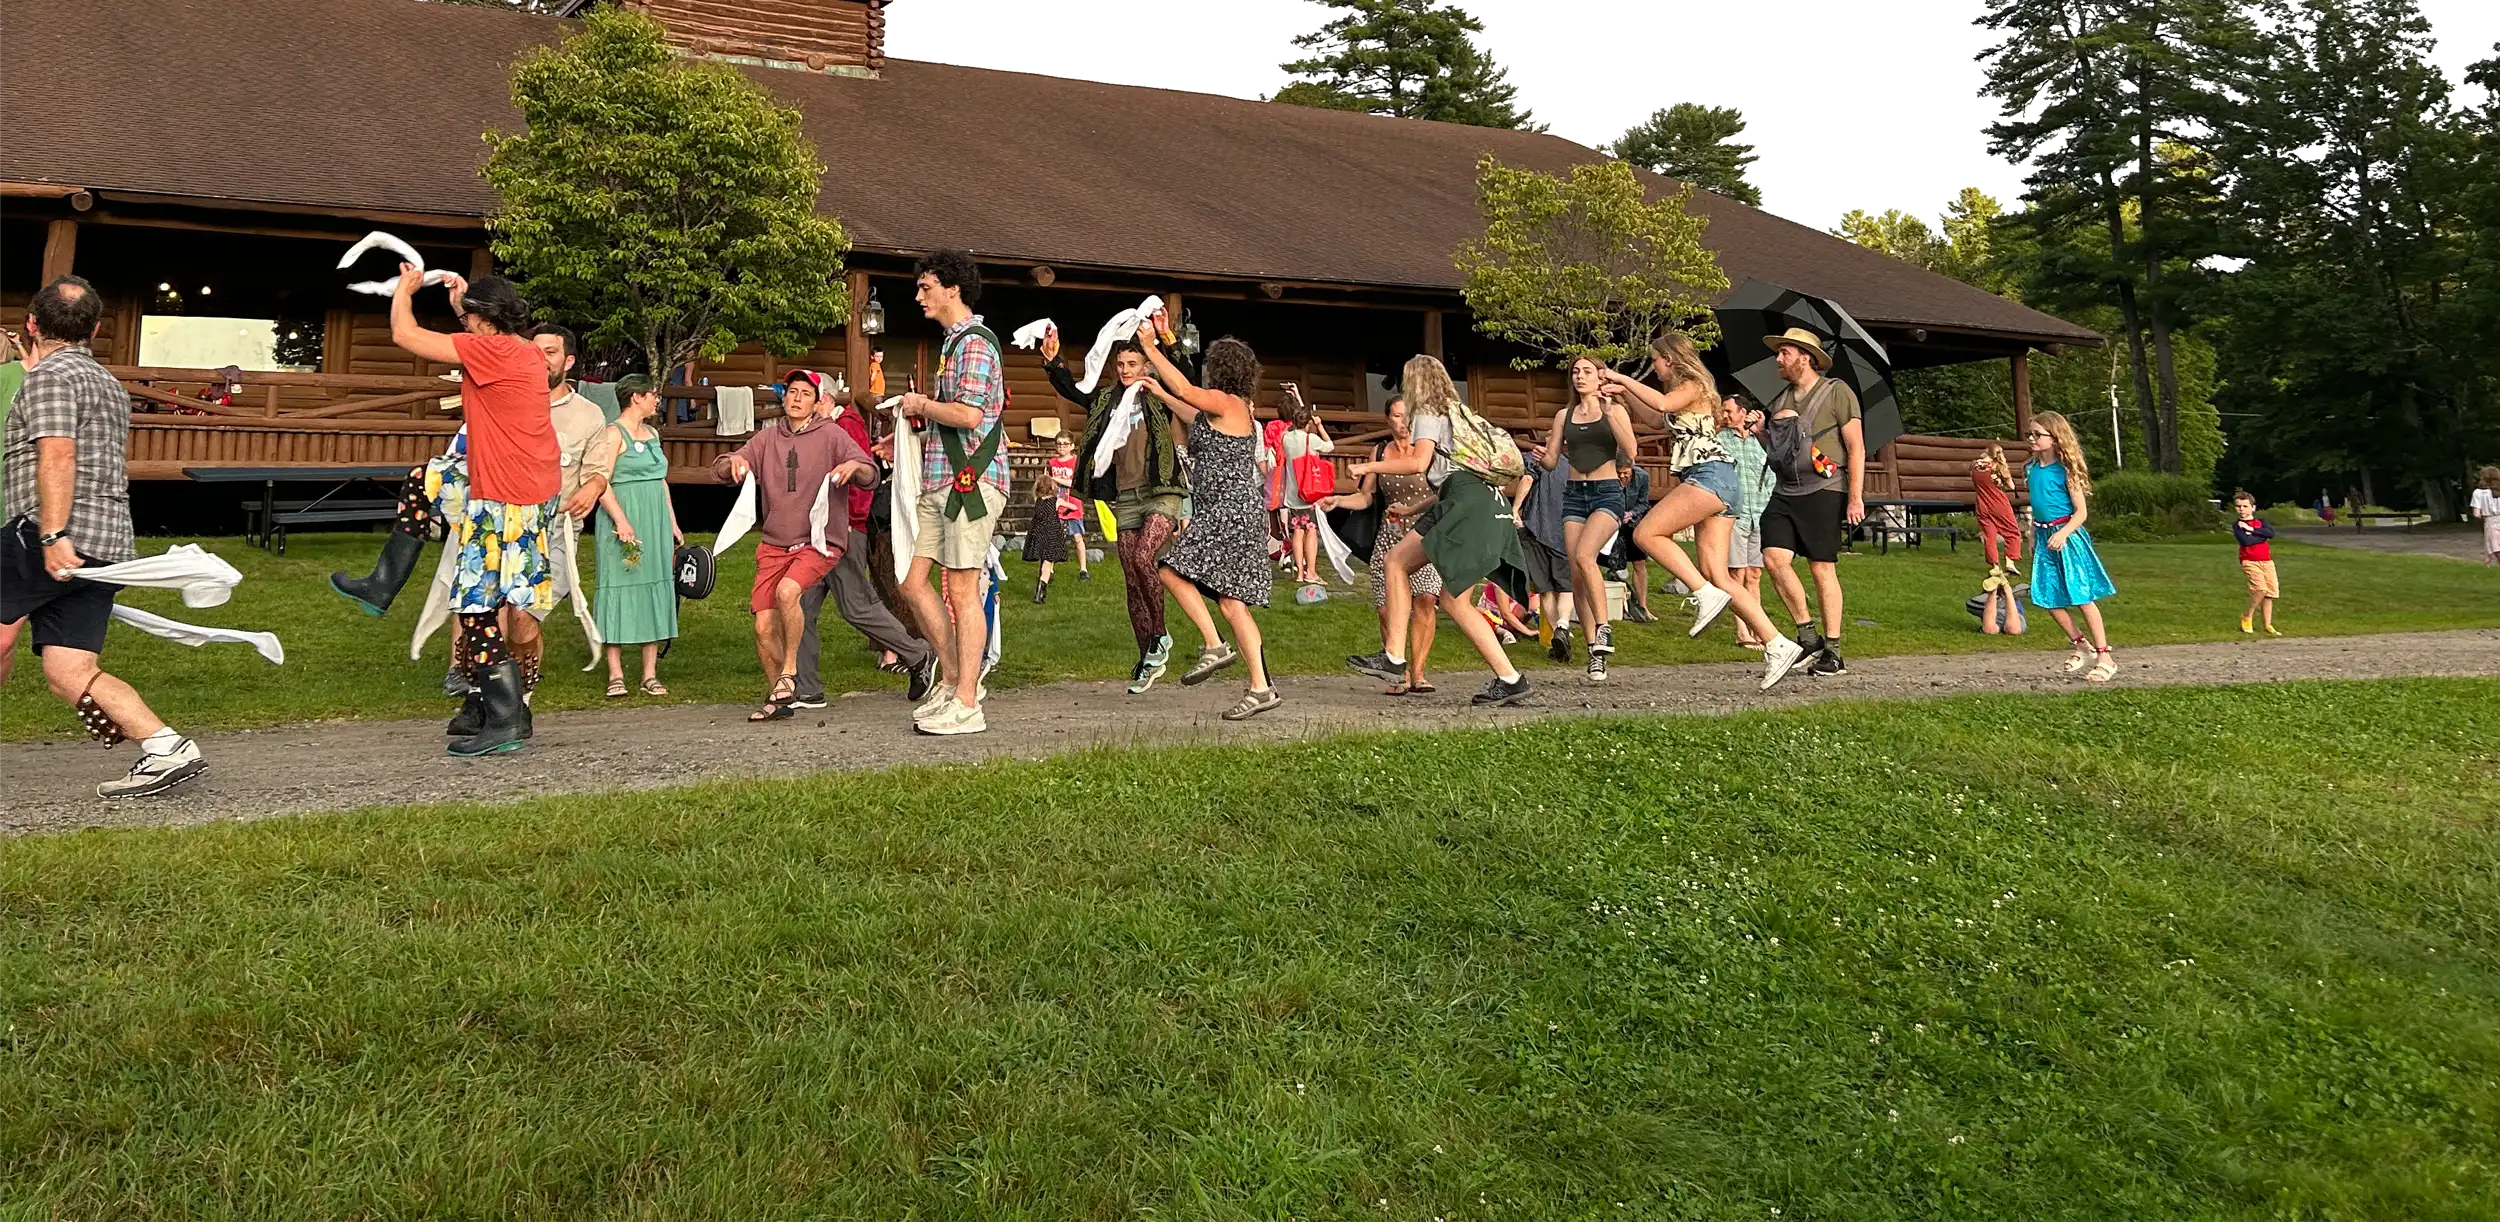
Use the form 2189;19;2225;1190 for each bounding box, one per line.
0;679;2500;1222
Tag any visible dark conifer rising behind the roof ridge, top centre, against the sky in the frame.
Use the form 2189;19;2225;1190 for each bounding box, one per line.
1275;0;1528;127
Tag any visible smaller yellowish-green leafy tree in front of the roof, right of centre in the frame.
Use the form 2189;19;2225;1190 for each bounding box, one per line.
1453;155;1728;370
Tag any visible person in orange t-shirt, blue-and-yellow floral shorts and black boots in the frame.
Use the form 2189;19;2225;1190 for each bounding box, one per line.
390;262;563;755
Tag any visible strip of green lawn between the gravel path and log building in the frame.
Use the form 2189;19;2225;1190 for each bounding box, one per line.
0;535;2500;740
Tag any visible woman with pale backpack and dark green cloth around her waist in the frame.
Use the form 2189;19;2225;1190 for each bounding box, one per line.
1353;357;1528;705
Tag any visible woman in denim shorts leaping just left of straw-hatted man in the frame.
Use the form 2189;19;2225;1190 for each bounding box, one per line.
1605;330;1805;692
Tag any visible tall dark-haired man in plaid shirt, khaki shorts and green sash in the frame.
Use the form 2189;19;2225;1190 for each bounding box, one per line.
903;250;1008;735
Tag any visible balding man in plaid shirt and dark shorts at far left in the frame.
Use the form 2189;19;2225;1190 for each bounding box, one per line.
0;275;208;797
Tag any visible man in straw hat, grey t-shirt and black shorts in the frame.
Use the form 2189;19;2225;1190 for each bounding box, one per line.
1763;327;1868;675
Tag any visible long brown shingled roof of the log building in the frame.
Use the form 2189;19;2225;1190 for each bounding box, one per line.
0;0;2098;342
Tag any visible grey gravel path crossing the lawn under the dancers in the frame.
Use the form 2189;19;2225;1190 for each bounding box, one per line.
0;630;2500;832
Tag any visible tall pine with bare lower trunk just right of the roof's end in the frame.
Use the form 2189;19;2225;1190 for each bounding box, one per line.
1973;0;2255;472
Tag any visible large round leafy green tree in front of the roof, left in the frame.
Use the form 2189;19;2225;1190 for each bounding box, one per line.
485;7;850;372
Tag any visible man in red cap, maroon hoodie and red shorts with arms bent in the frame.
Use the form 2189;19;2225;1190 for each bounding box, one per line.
713;367;878;722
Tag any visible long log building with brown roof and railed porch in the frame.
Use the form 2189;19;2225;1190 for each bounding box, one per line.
0;0;2100;509
